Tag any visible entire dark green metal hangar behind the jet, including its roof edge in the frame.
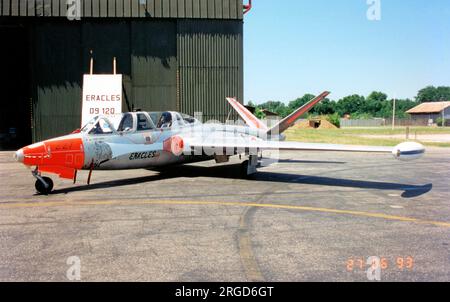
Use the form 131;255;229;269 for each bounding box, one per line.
0;0;244;149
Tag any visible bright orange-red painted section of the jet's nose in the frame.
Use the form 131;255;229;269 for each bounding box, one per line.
22;138;84;179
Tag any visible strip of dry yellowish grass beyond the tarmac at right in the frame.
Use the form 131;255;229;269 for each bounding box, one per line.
286;127;450;148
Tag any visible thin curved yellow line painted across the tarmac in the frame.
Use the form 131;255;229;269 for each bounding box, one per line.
0;200;450;228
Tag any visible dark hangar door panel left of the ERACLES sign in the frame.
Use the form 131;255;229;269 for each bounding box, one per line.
32;23;83;141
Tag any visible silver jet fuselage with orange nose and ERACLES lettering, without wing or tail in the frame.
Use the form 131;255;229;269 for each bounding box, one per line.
15;112;280;175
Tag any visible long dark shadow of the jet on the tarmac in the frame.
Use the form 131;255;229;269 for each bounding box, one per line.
50;164;433;198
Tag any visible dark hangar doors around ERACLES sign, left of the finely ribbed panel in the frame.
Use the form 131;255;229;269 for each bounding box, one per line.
32;20;178;141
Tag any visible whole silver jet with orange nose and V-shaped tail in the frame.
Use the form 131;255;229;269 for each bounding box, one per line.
14;92;425;194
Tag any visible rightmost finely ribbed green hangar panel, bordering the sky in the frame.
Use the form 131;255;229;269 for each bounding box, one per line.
178;20;243;121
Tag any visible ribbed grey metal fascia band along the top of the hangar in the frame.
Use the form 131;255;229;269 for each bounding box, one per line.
0;0;243;19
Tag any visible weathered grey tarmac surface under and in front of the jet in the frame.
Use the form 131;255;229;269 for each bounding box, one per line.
0;148;450;281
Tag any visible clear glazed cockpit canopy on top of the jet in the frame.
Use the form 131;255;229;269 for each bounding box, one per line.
81;111;199;135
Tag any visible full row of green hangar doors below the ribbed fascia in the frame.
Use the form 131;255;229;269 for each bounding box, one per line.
30;19;243;141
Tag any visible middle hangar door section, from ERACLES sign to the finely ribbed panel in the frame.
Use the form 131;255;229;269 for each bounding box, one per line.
81;20;177;117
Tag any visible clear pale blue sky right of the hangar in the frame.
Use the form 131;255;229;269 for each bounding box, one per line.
244;0;450;104
